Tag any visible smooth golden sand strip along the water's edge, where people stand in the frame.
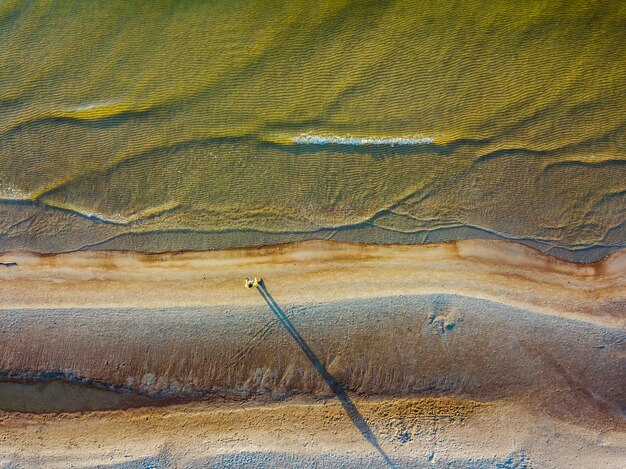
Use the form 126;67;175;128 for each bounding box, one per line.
0;240;626;327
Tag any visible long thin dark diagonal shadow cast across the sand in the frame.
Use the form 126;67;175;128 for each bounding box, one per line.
257;280;396;468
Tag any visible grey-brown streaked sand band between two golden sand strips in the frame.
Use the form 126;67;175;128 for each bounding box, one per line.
0;295;626;414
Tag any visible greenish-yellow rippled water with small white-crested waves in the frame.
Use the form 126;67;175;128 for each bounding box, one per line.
0;0;626;259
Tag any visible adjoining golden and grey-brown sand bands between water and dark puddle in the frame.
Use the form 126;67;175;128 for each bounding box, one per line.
0;241;626;420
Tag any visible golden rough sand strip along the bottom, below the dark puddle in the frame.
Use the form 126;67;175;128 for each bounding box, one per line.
0;398;626;468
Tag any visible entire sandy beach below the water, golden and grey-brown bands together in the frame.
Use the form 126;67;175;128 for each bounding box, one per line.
0;241;626;467
